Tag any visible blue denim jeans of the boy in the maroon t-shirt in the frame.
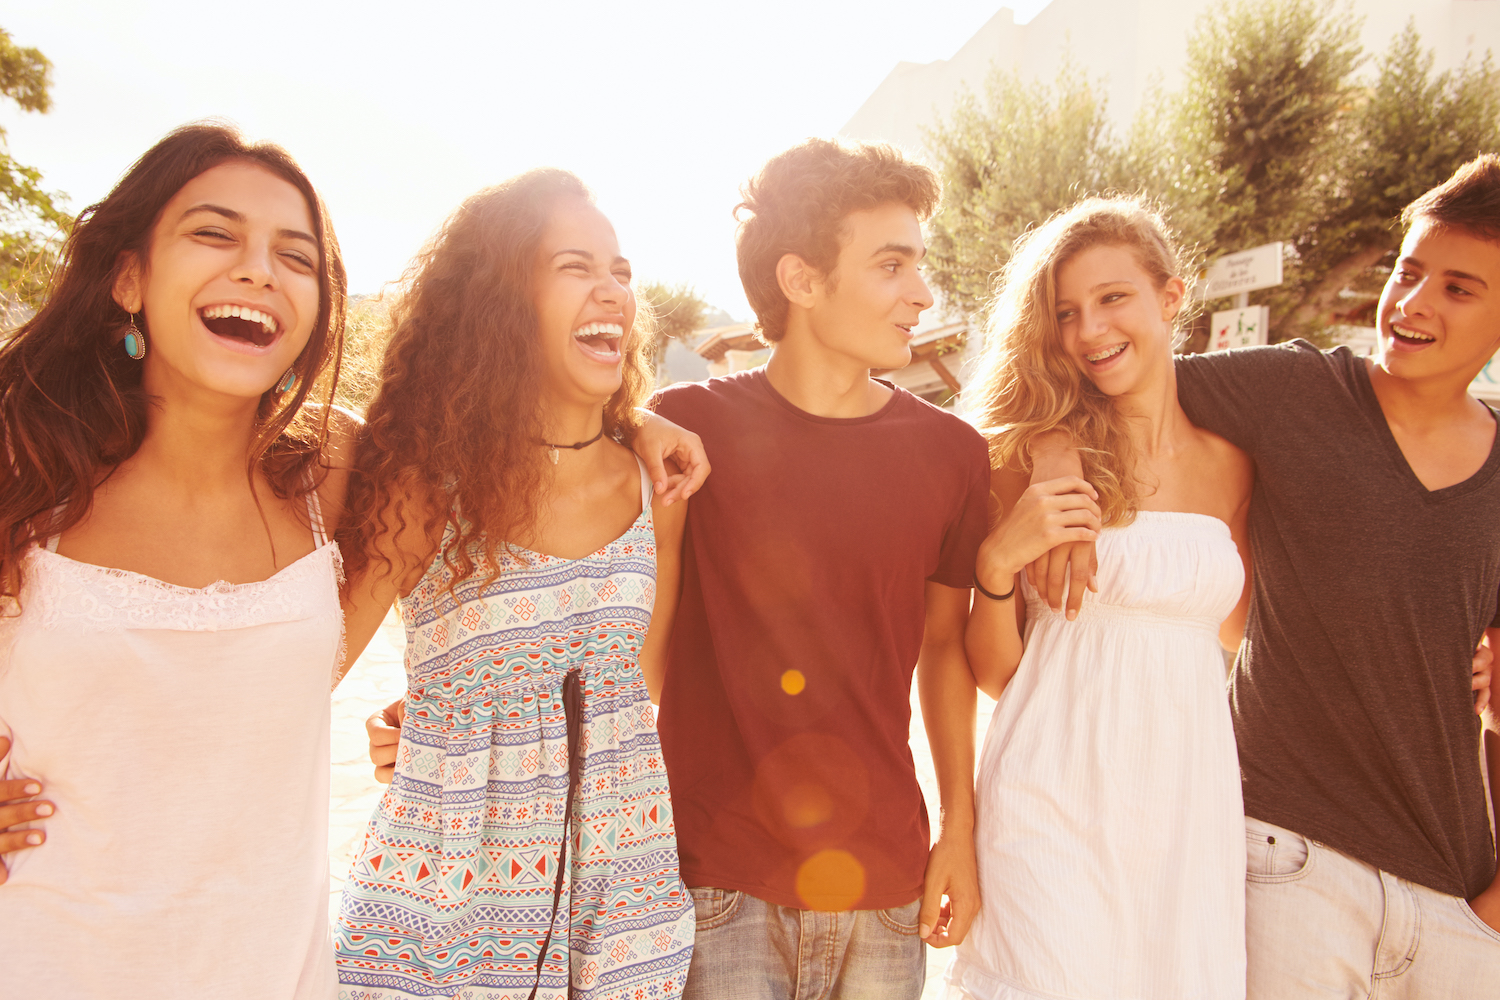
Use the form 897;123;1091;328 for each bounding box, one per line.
683;888;927;1000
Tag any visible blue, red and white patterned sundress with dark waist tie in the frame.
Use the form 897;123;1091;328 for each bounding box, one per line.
335;468;695;1000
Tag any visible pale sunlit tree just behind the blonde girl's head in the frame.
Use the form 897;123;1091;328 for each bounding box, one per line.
927;64;1125;313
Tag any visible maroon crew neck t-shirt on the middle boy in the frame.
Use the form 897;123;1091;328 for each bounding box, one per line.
656;369;990;910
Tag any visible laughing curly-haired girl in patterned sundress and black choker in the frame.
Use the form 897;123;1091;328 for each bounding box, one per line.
336;169;695;1000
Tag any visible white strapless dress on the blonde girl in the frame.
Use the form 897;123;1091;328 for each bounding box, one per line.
948;511;1245;1000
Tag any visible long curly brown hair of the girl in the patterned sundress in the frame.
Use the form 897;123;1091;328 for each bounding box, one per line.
338;168;653;585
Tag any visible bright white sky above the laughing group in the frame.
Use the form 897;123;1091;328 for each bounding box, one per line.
0;0;1047;319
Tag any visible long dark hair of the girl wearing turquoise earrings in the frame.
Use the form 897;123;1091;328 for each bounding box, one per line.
0;121;347;598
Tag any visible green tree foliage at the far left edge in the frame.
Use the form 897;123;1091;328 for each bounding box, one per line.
0;28;72;316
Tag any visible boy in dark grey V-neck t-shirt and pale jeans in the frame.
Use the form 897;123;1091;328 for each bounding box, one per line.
1034;156;1500;1000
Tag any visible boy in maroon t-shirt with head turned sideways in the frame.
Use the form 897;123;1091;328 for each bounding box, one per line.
647;139;990;1000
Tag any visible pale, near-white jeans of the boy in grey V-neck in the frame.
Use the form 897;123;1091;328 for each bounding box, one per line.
1245;817;1500;1000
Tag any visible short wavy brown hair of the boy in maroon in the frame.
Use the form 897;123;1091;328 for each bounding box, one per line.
735;139;942;343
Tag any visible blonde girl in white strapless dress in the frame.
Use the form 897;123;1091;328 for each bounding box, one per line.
948;199;1253;1000
